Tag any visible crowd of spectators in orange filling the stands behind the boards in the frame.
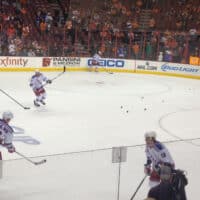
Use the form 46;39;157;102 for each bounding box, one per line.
0;0;200;63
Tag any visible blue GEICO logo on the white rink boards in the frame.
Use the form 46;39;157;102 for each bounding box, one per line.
88;59;124;67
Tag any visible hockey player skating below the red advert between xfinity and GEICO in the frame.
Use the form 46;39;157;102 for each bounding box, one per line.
30;69;52;107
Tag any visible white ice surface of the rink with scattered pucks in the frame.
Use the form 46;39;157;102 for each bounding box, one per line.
0;72;200;200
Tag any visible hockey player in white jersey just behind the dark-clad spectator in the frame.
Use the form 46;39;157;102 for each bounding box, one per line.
144;131;175;187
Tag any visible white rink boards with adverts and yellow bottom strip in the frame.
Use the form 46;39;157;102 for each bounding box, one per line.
0;57;200;79
